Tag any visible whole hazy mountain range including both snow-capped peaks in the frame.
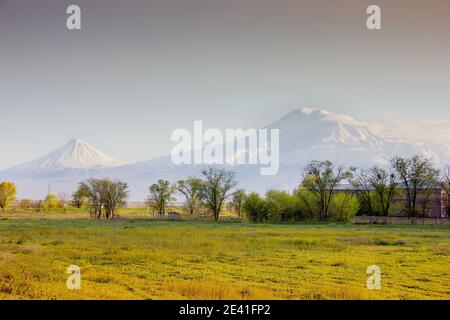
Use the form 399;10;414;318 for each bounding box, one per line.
0;108;450;201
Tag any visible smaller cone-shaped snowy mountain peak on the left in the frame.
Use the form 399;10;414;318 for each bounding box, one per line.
14;138;122;171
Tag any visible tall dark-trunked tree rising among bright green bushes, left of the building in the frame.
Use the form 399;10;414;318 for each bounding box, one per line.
302;161;351;220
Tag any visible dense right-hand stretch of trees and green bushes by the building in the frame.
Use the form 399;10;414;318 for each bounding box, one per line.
242;155;450;221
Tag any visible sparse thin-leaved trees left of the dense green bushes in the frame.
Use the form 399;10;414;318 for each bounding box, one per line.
72;167;237;220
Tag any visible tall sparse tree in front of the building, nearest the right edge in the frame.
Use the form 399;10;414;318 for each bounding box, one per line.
392;155;439;218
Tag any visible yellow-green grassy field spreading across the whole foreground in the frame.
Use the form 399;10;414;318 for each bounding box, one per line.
0;214;450;299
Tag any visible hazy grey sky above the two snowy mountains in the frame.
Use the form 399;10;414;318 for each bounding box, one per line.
0;0;450;169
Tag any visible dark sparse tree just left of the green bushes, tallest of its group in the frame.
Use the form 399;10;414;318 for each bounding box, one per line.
200;167;236;221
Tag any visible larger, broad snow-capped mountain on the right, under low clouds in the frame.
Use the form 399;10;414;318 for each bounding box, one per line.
268;108;450;167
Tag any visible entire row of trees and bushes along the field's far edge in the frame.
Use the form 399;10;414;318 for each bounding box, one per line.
0;155;450;222
